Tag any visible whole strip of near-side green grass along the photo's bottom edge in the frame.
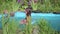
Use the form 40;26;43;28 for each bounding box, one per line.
2;18;59;34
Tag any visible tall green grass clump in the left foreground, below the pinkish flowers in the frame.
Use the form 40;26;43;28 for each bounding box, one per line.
2;12;18;34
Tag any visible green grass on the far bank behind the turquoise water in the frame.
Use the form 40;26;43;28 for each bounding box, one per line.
0;0;60;13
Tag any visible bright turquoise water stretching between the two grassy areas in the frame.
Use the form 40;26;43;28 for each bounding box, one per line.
0;12;60;31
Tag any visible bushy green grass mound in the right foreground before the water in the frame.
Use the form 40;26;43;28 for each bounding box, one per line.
38;19;58;34
